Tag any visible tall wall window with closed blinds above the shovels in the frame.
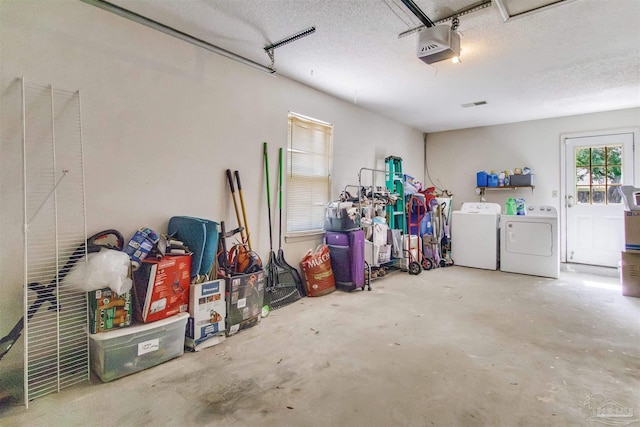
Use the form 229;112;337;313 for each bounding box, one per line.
286;113;333;236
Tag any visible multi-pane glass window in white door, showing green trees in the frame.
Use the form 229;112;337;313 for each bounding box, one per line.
575;145;622;204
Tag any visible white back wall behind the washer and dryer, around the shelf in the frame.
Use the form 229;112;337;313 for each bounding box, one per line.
426;108;640;210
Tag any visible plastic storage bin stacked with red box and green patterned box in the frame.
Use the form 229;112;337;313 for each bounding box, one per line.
89;255;191;382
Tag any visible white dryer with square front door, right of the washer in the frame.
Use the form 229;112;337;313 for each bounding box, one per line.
500;206;560;279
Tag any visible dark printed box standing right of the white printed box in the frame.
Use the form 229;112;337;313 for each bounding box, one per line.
225;270;264;336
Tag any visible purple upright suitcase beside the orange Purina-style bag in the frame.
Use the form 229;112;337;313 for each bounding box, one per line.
325;230;365;291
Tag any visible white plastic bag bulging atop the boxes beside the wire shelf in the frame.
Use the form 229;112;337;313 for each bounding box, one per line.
64;248;133;294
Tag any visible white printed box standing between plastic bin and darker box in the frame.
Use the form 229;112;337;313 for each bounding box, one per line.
185;279;227;351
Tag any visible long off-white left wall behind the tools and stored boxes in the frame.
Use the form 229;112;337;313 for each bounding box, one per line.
0;0;423;363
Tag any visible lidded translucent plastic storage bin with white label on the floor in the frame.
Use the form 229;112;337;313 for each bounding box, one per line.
89;313;189;382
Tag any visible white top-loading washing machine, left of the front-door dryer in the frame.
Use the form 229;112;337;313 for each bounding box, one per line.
451;203;501;270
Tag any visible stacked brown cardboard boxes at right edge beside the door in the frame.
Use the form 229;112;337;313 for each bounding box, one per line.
620;209;640;298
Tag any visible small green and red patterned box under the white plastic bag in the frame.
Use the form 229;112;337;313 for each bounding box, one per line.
87;288;133;334
